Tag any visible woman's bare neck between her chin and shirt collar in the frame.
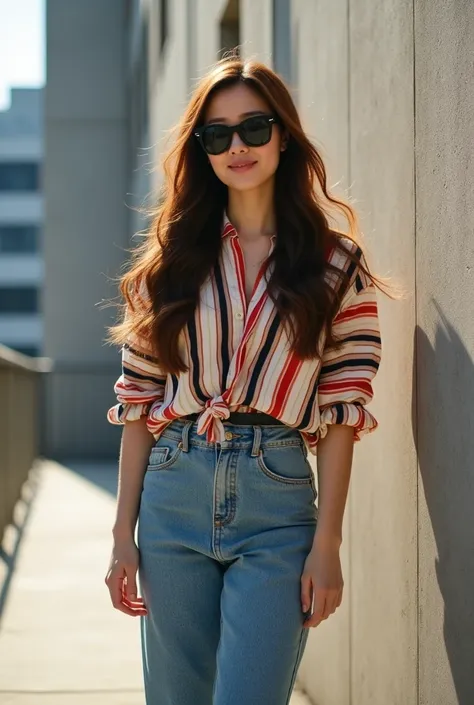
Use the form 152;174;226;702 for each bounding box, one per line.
227;184;276;241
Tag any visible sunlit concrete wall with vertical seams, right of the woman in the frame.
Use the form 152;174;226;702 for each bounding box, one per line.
292;0;474;705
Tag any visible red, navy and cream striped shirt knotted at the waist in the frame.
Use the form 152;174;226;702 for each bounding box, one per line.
107;216;381;455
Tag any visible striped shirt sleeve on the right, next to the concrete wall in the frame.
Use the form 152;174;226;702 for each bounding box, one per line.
318;264;382;441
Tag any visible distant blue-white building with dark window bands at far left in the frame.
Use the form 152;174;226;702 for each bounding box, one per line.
0;88;44;357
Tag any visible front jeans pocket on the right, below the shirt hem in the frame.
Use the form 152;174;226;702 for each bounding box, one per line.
257;443;313;485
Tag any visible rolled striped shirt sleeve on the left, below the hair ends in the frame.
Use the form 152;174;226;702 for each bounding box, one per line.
107;330;166;424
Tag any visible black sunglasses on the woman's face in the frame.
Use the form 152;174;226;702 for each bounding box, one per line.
194;115;277;155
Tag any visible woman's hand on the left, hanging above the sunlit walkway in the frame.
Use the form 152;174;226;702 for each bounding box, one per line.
105;537;148;617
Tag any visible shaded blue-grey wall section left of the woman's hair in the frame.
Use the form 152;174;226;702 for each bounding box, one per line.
43;0;129;457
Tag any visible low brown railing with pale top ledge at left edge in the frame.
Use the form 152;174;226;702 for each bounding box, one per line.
0;344;53;542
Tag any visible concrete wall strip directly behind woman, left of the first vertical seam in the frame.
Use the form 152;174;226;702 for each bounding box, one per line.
291;0;354;705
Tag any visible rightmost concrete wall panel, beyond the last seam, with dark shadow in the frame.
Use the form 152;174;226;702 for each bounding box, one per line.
414;0;474;705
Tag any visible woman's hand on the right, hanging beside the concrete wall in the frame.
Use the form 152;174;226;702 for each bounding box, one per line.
301;541;344;627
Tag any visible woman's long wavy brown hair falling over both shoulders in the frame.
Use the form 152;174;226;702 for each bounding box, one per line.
106;57;395;374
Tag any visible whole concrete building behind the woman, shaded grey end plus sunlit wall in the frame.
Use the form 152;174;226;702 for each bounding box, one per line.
45;0;474;705
